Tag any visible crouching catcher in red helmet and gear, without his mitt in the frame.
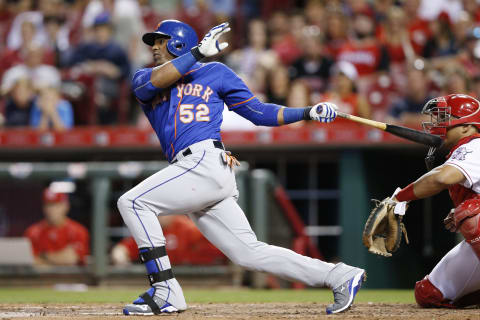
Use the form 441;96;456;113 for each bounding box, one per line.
390;94;480;308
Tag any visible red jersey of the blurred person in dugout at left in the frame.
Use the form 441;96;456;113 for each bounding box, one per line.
24;218;90;264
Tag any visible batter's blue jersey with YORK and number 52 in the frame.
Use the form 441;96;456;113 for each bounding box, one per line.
132;62;258;161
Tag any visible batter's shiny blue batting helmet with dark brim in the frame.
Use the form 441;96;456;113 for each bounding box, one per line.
142;20;198;57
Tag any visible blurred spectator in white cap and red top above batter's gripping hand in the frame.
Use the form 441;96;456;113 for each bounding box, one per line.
319;61;370;118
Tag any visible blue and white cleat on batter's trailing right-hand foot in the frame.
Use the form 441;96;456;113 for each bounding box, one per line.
326;269;367;314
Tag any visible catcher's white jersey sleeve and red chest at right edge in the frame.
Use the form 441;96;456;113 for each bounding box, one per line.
445;134;480;207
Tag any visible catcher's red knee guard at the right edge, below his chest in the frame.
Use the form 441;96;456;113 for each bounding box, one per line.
453;199;480;259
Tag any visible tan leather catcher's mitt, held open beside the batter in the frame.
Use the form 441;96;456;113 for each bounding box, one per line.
362;198;408;257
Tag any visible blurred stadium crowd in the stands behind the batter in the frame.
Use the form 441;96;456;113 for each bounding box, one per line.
0;0;480;130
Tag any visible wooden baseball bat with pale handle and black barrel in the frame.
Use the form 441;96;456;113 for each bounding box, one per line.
337;111;443;147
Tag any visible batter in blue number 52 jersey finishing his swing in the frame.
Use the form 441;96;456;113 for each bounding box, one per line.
118;20;365;315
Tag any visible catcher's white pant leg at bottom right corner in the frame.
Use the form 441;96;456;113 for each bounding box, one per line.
428;240;480;302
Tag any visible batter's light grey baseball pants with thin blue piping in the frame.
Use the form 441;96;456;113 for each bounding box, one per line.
118;140;358;308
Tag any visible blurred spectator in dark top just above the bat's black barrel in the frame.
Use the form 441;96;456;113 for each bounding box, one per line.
387;67;433;127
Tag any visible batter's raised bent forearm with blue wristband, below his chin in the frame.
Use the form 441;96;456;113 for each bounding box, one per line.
150;48;203;89
